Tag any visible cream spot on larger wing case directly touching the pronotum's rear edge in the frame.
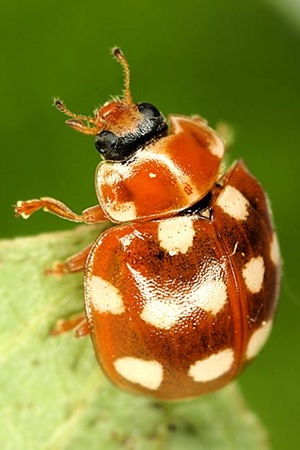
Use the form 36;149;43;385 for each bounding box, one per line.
158;217;195;256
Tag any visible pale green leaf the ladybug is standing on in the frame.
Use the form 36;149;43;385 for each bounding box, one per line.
0;226;268;450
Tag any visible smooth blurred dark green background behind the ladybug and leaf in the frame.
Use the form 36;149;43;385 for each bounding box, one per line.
0;0;300;450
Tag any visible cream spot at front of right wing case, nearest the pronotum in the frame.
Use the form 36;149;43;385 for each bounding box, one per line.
216;185;250;220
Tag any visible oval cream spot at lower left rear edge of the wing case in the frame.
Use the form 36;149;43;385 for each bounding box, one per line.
114;356;163;390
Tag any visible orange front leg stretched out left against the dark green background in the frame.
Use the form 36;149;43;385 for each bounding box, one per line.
15;197;109;224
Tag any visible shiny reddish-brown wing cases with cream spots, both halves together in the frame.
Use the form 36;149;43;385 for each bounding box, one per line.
85;162;280;399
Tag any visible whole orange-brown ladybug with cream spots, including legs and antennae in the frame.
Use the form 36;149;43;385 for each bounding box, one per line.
15;48;281;400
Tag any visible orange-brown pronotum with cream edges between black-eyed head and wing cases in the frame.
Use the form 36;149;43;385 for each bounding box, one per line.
96;116;224;222
